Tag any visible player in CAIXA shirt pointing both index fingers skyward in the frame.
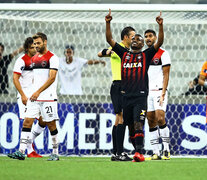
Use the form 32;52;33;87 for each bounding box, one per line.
105;10;164;162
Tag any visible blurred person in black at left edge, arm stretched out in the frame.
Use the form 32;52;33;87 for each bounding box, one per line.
0;43;23;94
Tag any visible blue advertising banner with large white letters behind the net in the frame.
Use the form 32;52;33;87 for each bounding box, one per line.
0;103;207;155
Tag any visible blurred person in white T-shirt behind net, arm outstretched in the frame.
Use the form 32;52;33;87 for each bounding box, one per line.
58;45;105;95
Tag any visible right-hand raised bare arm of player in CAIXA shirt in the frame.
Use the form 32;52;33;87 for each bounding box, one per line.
154;11;164;50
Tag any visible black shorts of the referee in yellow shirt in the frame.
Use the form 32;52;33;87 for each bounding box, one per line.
110;81;122;114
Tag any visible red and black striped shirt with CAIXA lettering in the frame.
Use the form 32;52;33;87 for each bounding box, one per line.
113;43;157;96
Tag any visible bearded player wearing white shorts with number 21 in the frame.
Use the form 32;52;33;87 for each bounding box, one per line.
9;32;59;161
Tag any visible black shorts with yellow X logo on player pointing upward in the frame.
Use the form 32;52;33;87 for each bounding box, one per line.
123;96;147;125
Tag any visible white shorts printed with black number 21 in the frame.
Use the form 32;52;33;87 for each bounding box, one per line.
25;100;59;122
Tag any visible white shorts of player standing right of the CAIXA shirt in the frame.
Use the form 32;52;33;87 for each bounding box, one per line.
147;90;168;112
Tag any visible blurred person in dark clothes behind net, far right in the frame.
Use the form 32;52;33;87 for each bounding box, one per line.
185;75;207;96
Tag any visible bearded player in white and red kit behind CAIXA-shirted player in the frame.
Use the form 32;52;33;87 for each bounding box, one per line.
144;29;171;160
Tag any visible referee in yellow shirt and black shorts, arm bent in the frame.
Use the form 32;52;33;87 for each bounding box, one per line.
98;26;135;161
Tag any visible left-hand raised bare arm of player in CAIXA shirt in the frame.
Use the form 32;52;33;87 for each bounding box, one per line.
105;9;116;47
